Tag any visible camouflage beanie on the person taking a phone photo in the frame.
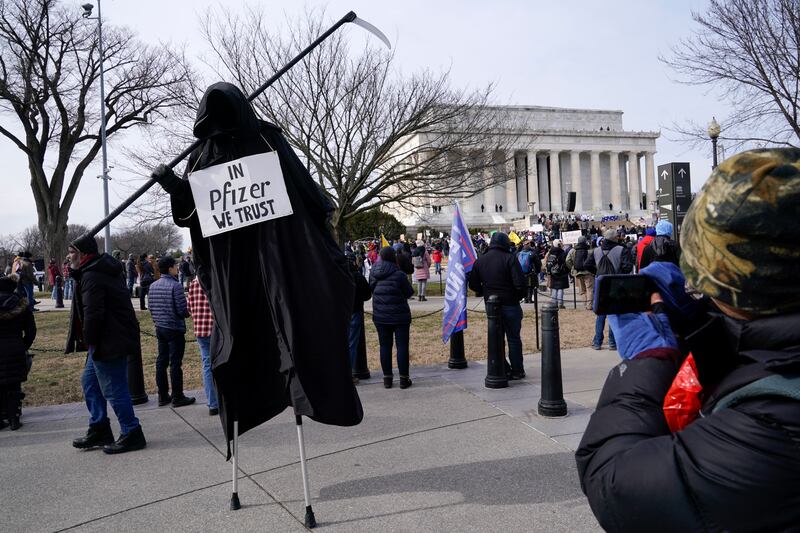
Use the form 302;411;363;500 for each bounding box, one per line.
681;148;800;315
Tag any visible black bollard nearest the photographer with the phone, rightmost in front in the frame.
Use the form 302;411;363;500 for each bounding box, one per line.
539;304;567;417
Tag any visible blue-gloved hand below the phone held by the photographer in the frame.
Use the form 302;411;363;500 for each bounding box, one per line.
608;313;678;359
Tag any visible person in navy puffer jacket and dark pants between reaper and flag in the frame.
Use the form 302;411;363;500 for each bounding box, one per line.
369;246;414;389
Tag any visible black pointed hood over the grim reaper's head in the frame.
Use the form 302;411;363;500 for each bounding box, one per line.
193;81;259;139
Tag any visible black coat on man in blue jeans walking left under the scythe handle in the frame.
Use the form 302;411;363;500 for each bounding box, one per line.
64;254;142;361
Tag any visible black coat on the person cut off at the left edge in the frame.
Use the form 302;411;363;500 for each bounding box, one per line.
0;292;36;385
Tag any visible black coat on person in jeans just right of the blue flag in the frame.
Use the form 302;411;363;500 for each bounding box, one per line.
469;245;528;305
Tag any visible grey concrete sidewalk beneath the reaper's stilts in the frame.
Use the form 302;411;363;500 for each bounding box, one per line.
0;349;618;532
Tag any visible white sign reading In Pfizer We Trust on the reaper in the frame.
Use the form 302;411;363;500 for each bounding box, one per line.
189;152;292;237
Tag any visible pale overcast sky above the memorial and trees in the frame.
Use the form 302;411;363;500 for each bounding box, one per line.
0;0;727;246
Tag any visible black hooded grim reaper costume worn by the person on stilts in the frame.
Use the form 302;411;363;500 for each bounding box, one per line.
153;82;363;448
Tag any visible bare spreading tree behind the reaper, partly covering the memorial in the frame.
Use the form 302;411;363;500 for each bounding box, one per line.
204;10;521;240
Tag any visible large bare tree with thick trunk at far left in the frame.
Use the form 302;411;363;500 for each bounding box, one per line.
0;0;195;264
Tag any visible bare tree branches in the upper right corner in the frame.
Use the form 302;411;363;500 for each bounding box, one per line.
661;0;800;148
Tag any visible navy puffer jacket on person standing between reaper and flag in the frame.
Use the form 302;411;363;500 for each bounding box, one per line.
369;260;414;324
